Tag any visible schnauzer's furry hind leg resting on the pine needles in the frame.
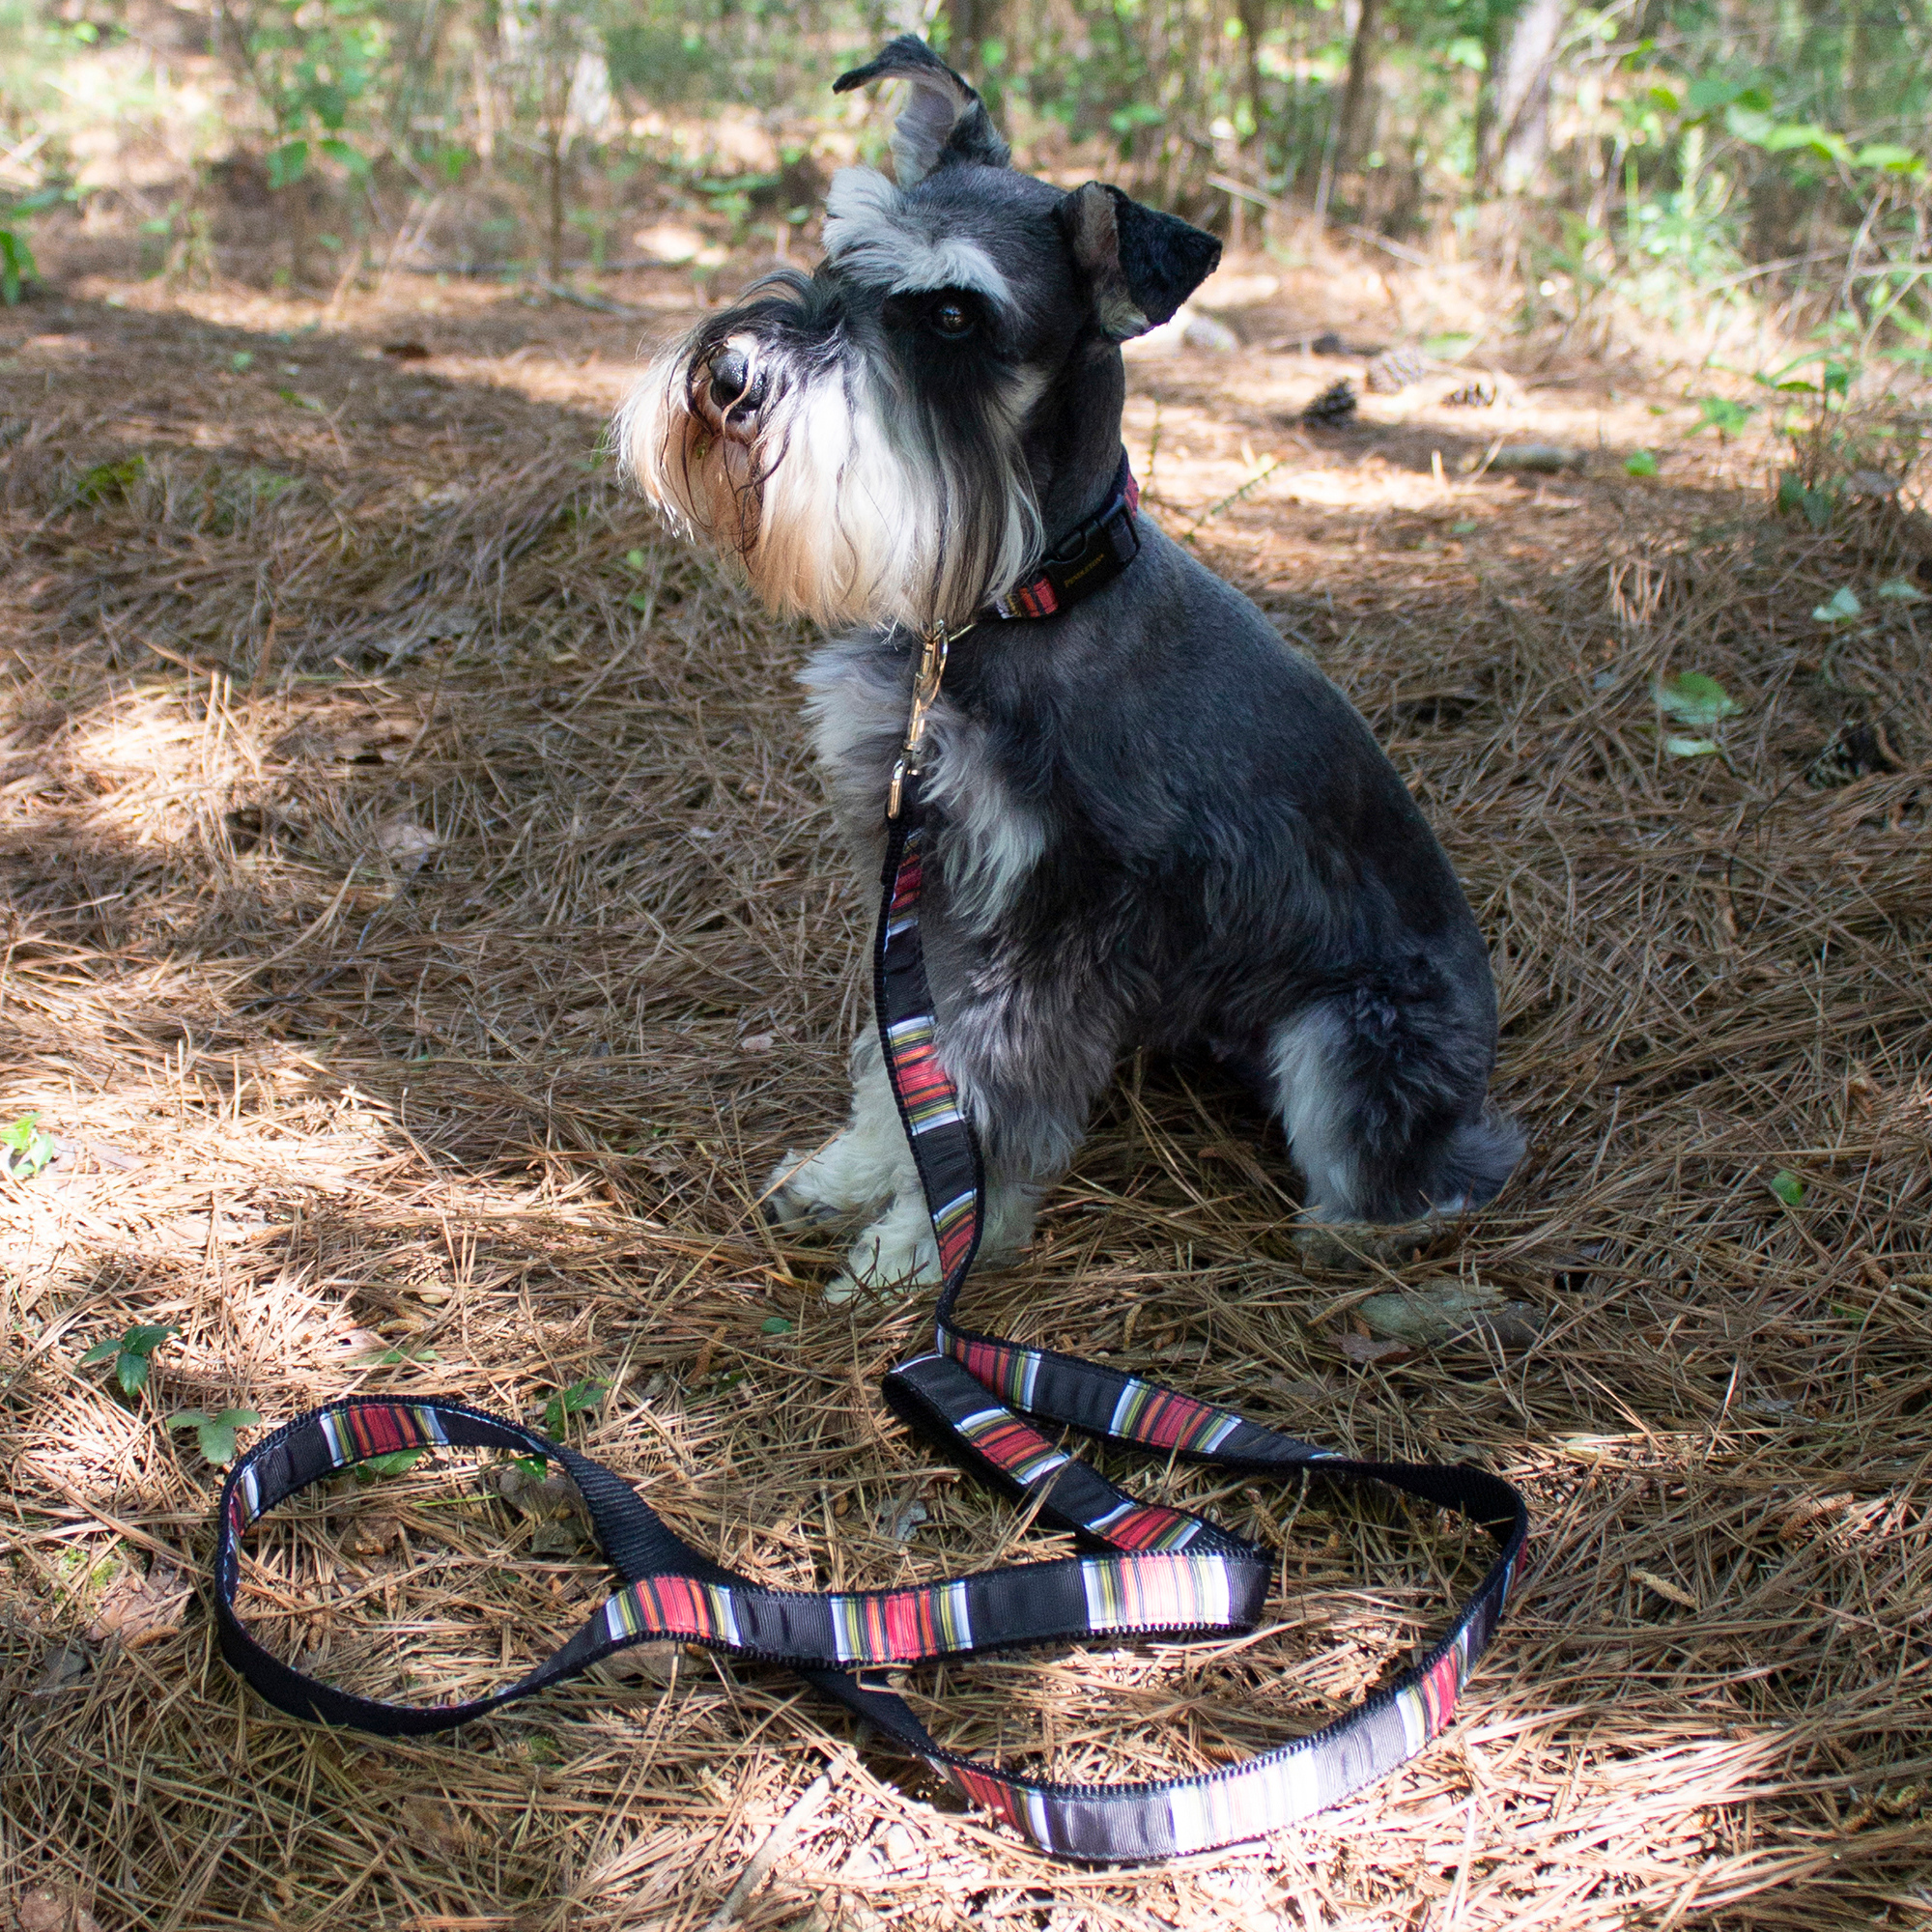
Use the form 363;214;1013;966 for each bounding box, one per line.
1271;976;1522;1262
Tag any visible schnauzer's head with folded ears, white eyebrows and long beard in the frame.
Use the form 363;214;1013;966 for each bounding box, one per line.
618;35;1221;626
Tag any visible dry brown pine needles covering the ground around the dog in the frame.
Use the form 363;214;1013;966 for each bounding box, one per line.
0;257;1932;1932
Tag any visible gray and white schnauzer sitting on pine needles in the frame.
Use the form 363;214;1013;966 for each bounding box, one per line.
618;35;1522;1293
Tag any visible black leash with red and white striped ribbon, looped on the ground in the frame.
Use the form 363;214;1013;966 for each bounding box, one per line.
214;458;1528;1862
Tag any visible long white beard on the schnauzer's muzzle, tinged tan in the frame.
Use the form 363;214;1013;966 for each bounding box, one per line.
618;338;1039;628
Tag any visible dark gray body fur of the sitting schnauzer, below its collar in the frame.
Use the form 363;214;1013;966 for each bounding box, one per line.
806;522;1520;1221
